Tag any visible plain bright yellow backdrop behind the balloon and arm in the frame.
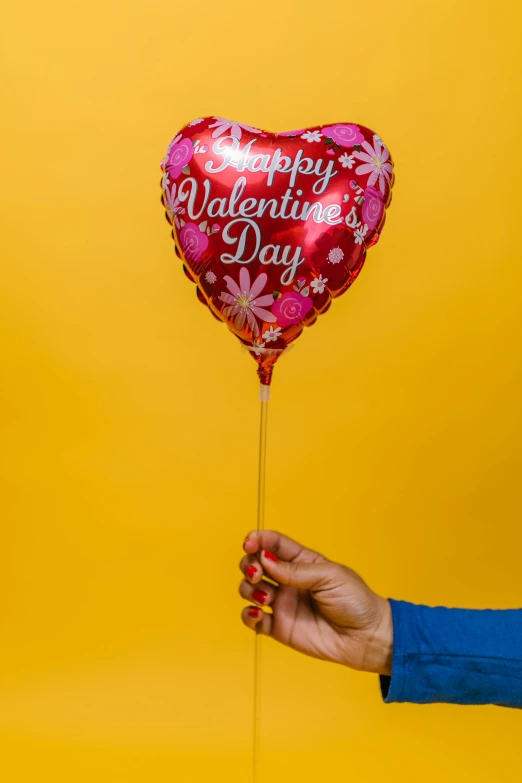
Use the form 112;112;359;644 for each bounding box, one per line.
0;0;522;783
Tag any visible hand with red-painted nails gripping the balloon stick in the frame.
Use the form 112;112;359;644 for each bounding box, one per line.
239;531;393;675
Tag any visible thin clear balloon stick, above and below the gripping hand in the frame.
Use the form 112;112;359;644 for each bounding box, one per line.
252;385;270;783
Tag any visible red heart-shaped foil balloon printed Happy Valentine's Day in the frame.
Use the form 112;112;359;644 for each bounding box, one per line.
161;117;394;384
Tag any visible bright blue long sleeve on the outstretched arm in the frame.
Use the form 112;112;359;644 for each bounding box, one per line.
380;599;522;709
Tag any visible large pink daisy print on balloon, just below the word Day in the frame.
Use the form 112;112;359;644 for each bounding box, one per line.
219;267;276;337
